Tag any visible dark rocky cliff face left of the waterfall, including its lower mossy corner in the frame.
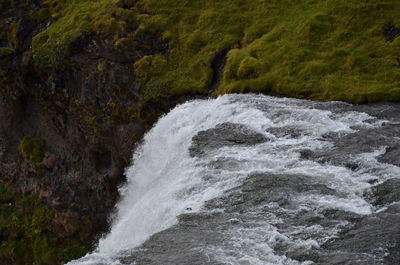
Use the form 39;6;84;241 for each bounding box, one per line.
0;1;191;264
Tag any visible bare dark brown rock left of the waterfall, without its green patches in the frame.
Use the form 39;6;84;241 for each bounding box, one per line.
0;0;177;258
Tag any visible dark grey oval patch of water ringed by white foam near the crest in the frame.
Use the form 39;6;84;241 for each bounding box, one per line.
189;123;268;156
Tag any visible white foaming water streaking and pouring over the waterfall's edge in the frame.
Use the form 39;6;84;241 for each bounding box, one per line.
68;95;400;265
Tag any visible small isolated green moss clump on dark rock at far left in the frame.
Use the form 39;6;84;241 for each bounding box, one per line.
19;137;44;169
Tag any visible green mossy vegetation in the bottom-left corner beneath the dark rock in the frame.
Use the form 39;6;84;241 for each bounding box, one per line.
0;177;87;265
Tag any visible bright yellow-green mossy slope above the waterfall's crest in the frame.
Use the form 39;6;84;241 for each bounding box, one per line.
33;0;400;103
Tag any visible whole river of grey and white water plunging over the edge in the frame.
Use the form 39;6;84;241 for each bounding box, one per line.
68;95;400;265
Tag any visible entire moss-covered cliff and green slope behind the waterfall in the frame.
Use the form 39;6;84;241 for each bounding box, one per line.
0;0;400;264
